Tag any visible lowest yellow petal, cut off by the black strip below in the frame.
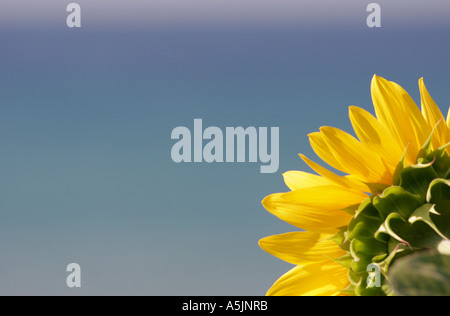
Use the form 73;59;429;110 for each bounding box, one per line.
267;260;349;296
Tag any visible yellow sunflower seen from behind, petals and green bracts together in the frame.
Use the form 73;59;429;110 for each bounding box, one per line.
259;75;450;296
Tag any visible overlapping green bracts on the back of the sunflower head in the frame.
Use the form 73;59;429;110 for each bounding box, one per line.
334;142;450;295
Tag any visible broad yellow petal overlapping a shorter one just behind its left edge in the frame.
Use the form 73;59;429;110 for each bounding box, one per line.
320;127;392;184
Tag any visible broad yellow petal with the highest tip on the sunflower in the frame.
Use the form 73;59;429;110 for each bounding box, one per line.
371;75;432;163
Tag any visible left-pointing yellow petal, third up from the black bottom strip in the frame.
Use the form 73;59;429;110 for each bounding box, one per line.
262;192;351;234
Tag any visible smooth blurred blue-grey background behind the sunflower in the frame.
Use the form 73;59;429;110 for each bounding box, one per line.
0;0;450;295
